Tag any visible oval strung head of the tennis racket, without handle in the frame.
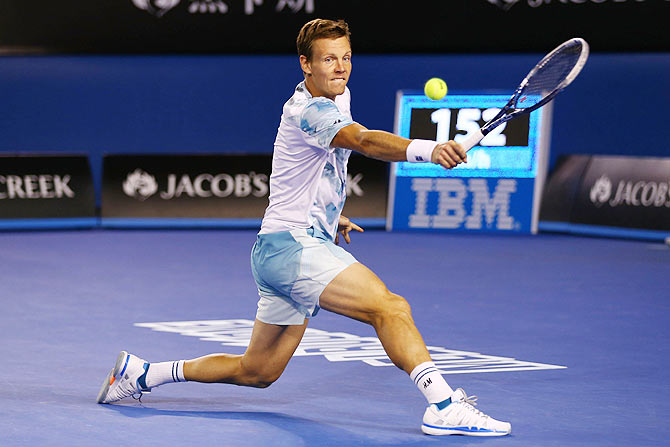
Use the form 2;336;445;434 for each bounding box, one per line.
510;37;589;112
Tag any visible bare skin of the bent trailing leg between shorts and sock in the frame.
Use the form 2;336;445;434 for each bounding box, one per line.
184;319;307;388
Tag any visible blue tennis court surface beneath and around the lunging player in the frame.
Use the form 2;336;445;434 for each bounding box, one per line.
0;230;670;447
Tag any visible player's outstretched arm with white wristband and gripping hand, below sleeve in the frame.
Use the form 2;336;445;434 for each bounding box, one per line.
331;123;467;169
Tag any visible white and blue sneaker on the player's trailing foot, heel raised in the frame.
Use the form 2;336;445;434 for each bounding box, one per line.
98;351;151;404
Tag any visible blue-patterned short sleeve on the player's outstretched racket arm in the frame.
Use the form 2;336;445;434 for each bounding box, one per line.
300;97;353;151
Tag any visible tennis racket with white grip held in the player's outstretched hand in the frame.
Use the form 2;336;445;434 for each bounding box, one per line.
461;38;589;152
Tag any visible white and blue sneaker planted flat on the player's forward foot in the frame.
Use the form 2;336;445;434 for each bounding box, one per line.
421;388;512;436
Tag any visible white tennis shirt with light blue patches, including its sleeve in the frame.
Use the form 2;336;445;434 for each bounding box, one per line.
259;81;354;239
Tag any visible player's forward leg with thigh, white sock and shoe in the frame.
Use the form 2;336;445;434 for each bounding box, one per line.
319;263;511;436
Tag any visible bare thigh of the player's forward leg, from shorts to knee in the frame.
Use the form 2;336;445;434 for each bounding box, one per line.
319;262;405;323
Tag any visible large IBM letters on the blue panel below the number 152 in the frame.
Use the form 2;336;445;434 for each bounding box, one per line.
409;178;518;230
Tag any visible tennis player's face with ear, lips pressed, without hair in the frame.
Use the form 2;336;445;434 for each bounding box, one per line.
300;37;351;100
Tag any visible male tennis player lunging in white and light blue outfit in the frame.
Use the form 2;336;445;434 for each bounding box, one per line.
98;19;511;436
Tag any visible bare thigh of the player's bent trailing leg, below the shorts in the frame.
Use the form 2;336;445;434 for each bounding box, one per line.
242;319;308;373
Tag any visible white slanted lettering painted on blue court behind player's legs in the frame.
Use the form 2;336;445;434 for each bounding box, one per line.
135;320;566;374
